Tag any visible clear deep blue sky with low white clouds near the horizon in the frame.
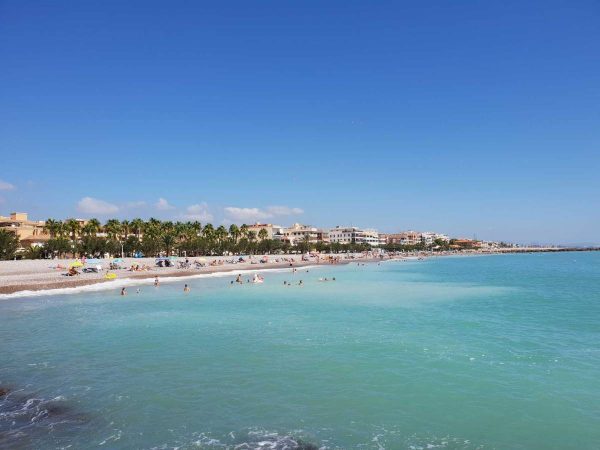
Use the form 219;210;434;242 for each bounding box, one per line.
0;0;600;243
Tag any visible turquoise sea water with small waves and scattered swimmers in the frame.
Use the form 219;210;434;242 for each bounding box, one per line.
0;253;600;449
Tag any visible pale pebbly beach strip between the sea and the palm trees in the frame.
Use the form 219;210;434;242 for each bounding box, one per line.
0;254;379;294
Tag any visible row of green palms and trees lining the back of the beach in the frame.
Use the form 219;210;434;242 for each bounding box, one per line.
0;218;370;259
